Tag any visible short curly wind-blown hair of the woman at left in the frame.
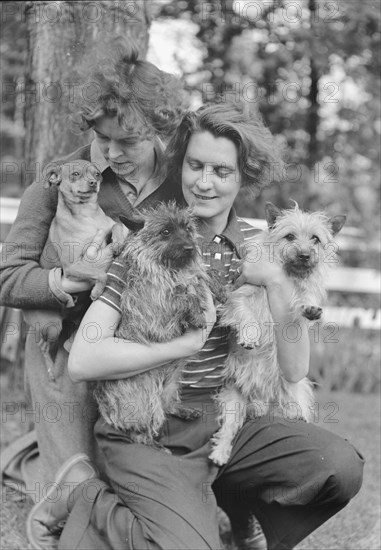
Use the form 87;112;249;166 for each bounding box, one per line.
71;39;185;139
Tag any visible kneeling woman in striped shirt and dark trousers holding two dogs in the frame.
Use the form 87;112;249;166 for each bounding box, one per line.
30;104;363;550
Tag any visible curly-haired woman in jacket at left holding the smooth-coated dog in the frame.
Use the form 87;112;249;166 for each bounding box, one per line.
1;40;183;508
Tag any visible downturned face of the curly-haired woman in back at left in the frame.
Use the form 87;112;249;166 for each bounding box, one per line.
93;116;154;178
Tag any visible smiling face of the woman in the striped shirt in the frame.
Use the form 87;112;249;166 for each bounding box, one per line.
182;132;241;232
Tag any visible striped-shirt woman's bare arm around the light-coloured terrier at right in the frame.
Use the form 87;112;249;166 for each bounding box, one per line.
236;258;310;382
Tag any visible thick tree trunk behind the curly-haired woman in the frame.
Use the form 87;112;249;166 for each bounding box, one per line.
24;0;150;185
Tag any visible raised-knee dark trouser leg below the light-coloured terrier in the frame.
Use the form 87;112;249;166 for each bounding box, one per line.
213;418;364;549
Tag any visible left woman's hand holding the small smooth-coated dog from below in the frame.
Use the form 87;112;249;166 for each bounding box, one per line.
61;229;115;293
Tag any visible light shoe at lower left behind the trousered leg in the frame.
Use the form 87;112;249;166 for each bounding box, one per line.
26;454;99;550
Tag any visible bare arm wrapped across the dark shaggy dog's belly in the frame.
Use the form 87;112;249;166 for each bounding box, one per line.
68;296;216;382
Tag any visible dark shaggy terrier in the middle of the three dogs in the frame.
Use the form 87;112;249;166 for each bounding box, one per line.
95;203;209;445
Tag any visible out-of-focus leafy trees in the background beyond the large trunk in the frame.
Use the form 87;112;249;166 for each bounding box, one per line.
0;0;381;241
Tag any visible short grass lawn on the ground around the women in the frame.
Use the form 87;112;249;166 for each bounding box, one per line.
0;374;381;550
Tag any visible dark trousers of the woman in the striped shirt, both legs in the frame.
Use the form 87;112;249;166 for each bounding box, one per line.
60;392;363;550
